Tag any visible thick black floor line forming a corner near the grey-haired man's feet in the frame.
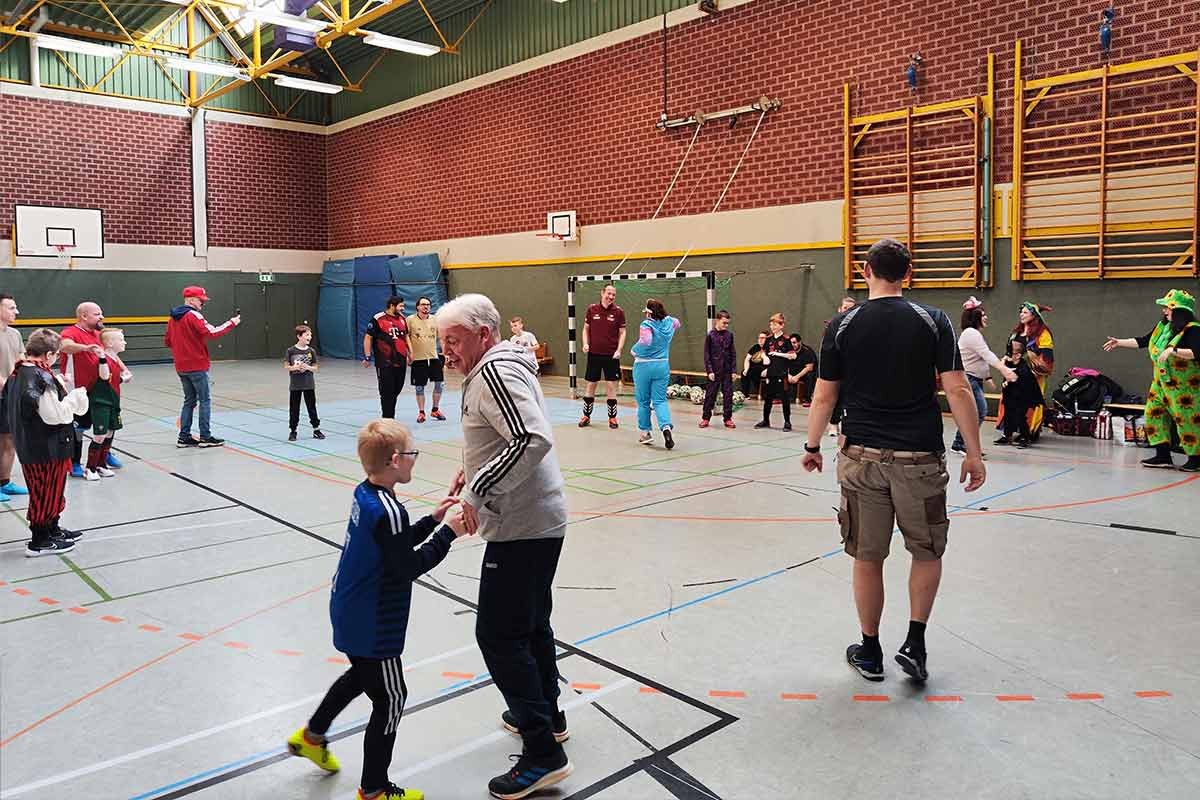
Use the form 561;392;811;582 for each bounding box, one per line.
136;460;734;800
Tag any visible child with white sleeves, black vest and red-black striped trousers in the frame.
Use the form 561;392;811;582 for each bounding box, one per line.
0;327;88;558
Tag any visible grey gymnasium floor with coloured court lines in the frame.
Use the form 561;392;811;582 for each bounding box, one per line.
0;361;1200;800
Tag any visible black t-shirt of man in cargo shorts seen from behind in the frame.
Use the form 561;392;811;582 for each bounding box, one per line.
820;297;962;452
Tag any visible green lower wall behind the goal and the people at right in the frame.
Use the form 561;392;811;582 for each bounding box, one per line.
450;240;1180;395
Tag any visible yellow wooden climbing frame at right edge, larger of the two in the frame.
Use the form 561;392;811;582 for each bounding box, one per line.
1010;41;1200;281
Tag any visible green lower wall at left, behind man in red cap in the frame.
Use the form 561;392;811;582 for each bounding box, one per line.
0;269;320;363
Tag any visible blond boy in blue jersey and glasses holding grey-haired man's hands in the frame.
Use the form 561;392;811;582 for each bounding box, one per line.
288;420;467;800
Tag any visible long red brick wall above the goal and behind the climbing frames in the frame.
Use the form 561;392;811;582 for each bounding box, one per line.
328;0;1200;248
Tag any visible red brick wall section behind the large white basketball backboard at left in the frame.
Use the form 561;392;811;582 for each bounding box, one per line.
0;95;192;245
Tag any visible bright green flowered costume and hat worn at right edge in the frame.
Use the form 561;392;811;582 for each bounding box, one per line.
1146;289;1200;456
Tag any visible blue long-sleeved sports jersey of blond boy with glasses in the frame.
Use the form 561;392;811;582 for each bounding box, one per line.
329;481;455;658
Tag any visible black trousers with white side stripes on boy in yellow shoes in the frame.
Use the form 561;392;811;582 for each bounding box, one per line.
308;656;408;794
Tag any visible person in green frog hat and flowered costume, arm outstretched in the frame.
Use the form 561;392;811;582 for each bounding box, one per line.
1104;289;1200;473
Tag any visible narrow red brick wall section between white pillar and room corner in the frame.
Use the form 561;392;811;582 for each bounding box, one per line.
206;122;326;249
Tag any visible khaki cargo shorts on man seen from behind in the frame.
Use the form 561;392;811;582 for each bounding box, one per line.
838;445;950;561
